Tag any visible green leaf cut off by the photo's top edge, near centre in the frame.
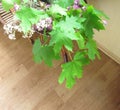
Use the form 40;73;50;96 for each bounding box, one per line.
54;0;74;8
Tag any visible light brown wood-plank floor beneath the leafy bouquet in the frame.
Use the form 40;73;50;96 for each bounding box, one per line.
0;26;120;110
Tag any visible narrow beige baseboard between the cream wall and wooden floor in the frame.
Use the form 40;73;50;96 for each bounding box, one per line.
97;42;120;64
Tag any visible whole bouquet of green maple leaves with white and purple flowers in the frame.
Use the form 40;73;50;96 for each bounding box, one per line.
2;0;107;88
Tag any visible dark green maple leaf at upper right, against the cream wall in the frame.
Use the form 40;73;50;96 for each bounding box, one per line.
83;6;105;38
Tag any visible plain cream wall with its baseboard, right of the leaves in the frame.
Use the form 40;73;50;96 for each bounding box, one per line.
88;0;120;63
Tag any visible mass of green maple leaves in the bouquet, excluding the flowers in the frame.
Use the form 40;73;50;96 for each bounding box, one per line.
2;0;107;88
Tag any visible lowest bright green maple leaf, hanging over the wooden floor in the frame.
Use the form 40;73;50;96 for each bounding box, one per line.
58;61;83;88
